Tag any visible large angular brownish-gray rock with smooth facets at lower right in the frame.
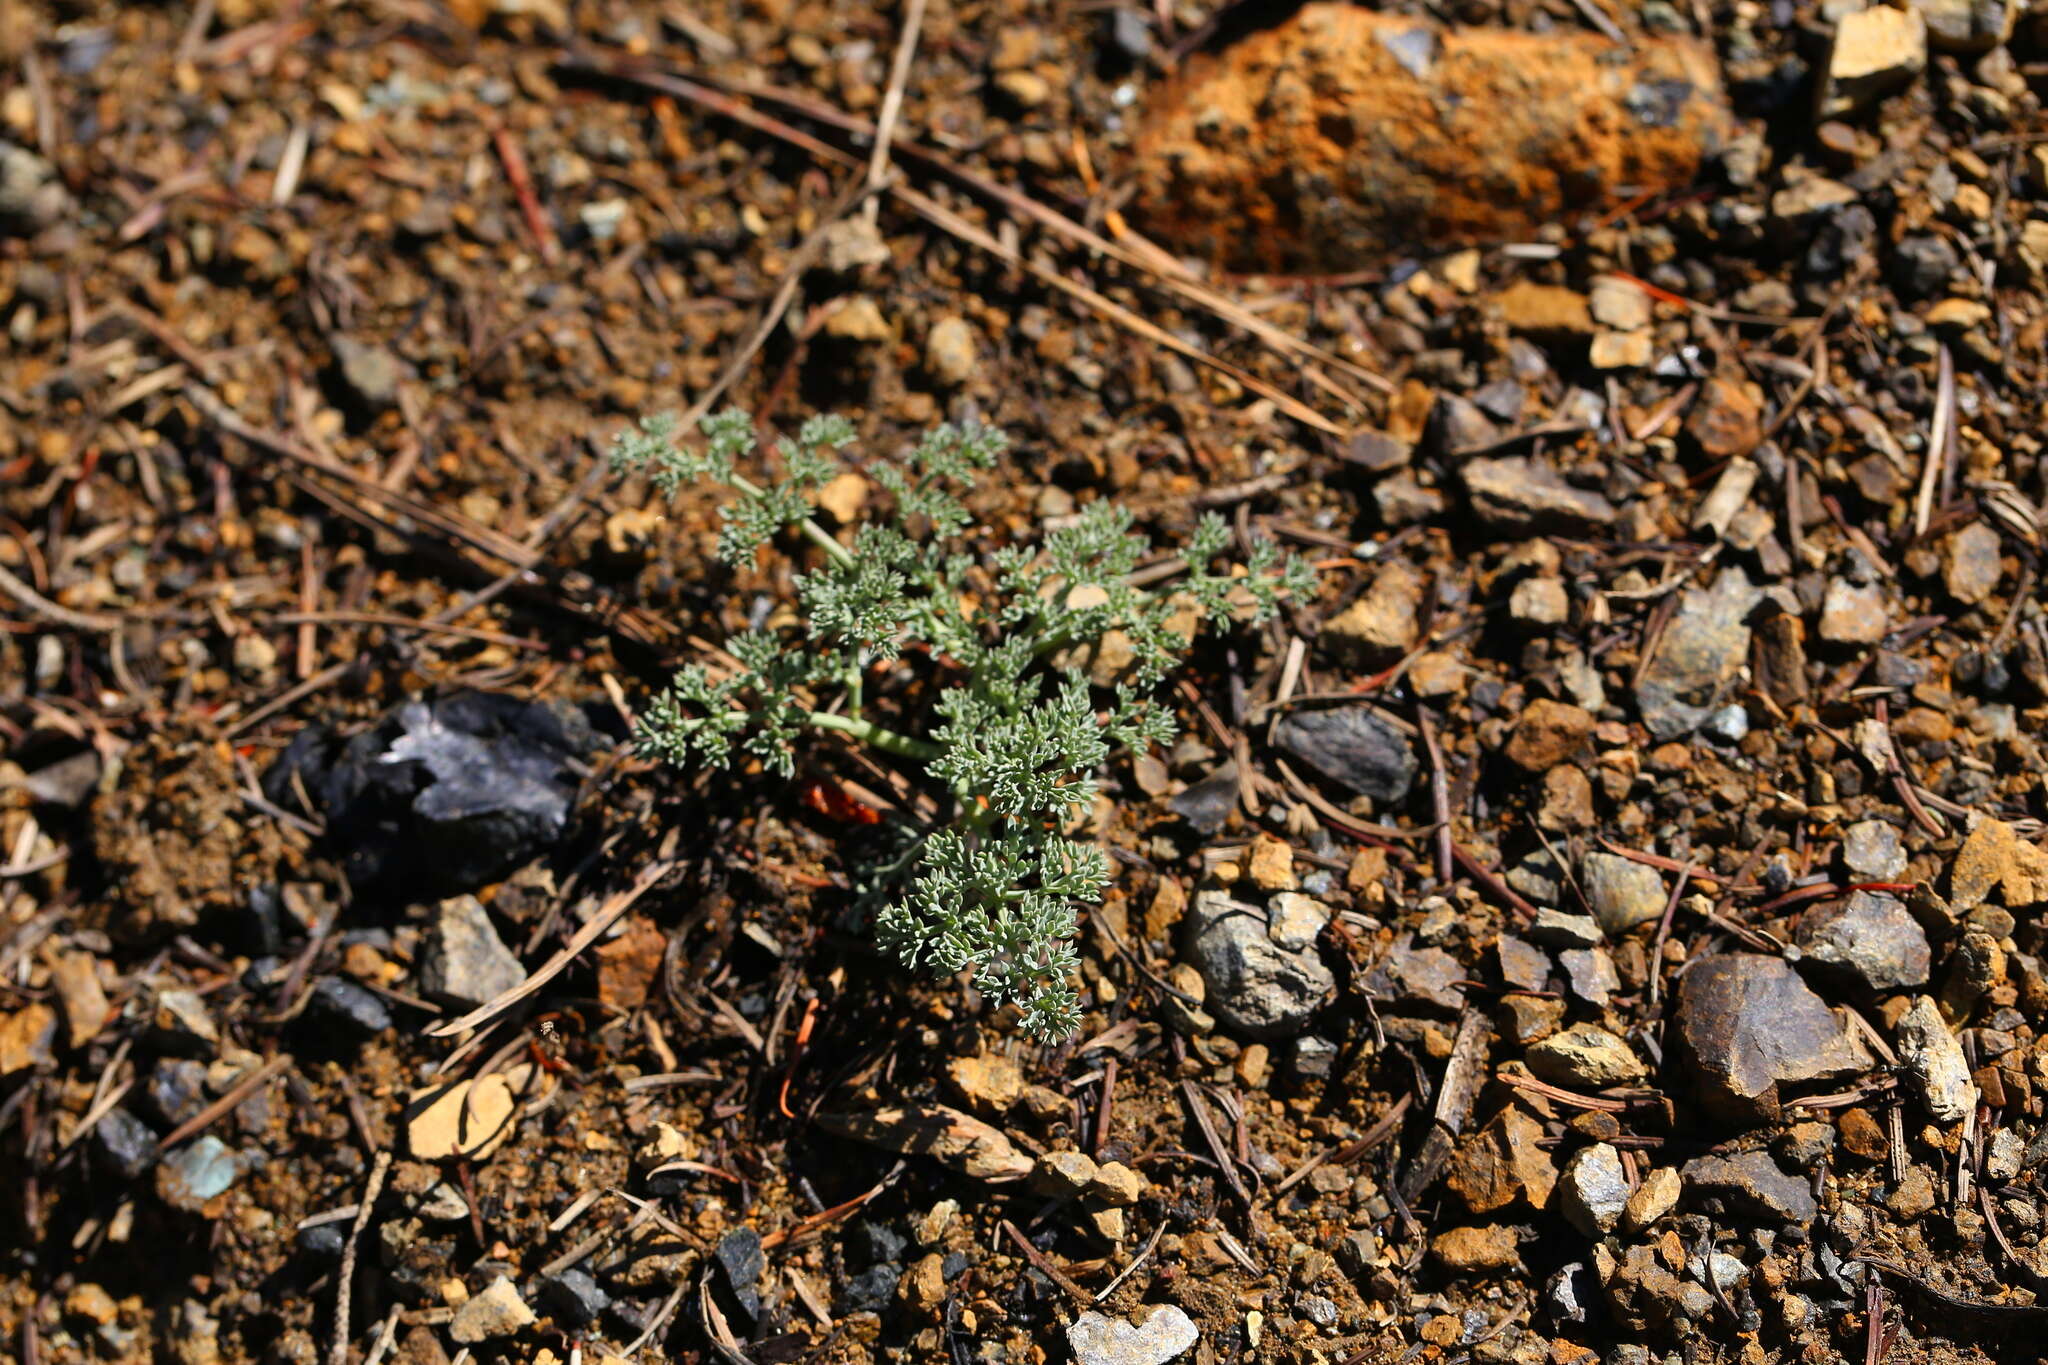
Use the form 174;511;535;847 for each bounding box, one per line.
1677;954;1870;1124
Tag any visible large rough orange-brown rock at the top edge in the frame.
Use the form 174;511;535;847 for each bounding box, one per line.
1137;0;1733;270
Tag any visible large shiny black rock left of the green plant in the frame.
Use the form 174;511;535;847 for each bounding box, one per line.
262;692;596;900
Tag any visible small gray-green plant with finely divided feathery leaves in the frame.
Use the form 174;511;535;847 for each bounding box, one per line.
612;409;1315;1040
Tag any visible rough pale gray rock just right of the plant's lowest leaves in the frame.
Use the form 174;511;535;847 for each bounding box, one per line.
1184;890;1337;1040
